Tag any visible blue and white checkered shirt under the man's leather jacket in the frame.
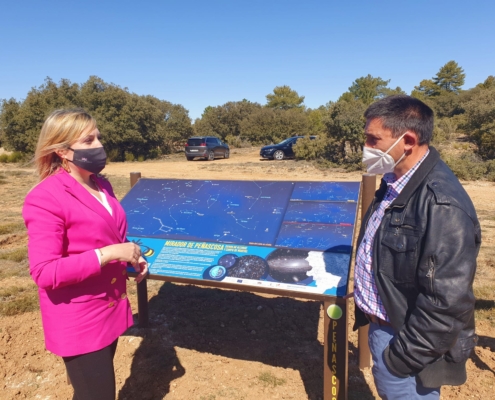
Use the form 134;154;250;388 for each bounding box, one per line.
354;150;430;321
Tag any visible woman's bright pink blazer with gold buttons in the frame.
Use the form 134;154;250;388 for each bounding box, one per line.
22;170;132;357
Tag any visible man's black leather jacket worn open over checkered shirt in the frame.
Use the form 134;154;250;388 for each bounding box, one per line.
354;147;481;388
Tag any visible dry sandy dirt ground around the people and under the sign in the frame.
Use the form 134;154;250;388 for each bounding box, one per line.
0;148;495;400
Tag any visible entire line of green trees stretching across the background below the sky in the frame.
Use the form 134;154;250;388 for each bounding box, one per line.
0;61;495;180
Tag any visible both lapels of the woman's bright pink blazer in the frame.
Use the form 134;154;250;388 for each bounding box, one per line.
59;171;125;243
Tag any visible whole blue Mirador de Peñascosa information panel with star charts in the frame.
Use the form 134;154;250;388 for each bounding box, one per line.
121;179;360;296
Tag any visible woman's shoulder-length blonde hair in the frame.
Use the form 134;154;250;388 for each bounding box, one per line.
34;108;96;181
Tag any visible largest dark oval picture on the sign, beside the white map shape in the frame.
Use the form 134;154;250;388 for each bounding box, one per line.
266;249;311;283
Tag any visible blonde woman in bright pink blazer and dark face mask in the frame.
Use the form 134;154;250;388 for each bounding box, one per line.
22;109;148;400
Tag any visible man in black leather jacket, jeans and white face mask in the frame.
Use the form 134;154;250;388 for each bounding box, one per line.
354;95;481;399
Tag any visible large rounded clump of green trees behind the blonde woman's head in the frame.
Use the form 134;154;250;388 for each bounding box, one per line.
0;76;193;161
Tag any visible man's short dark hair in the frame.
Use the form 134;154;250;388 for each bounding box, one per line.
364;94;433;145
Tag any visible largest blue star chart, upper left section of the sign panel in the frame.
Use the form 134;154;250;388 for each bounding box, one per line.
121;179;294;246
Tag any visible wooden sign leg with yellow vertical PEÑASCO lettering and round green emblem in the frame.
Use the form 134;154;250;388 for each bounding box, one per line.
323;297;349;400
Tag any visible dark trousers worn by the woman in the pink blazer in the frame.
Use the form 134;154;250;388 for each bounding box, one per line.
63;339;118;400
